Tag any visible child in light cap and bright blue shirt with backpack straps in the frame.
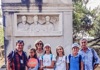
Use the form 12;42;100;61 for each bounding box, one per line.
67;43;83;70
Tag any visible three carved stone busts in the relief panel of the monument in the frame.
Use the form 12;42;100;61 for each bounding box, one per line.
17;15;54;32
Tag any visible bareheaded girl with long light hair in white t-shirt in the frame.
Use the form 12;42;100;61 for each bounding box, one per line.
55;46;67;70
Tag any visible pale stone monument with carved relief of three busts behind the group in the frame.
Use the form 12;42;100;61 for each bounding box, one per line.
2;0;73;55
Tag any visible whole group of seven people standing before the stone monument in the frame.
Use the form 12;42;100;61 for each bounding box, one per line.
7;39;100;70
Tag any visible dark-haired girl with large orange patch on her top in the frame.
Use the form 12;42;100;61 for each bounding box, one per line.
27;48;39;70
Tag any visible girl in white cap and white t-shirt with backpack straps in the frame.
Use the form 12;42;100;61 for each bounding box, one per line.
40;44;56;70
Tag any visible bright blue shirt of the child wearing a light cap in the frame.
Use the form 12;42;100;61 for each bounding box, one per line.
67;54;82;70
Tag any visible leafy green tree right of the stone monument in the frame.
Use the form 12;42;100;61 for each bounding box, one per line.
73;0;100;46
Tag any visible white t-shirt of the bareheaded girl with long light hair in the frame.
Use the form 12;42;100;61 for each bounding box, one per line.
55;56;67;70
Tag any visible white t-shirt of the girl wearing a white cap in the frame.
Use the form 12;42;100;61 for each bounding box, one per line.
40;54;56;70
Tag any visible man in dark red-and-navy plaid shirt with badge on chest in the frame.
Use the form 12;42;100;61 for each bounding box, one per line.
7;40;27;70
